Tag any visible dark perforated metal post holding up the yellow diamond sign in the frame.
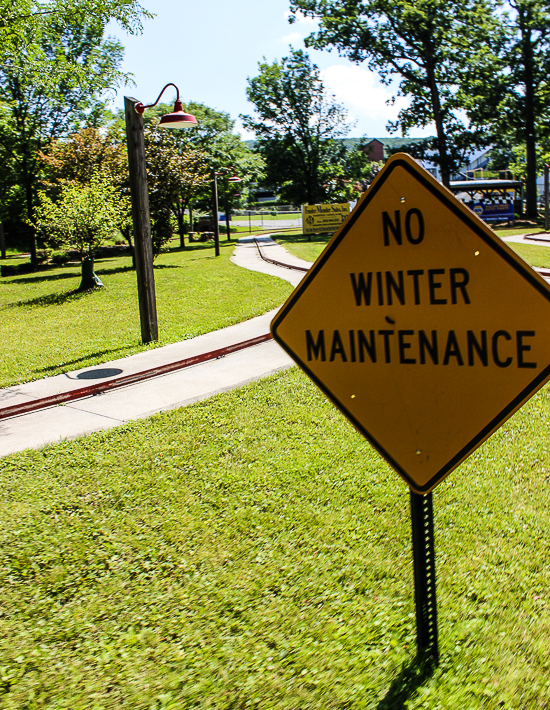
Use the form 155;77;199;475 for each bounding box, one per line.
411;491;439;664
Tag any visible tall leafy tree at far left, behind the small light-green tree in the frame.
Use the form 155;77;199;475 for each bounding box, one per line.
0;20;126;262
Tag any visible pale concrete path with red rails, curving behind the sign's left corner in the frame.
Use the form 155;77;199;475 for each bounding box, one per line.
0;240;307;455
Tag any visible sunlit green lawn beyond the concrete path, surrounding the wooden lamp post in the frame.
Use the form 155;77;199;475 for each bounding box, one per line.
0;241;292;386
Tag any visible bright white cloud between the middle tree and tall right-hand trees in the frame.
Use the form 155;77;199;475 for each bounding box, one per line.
321;64;433;136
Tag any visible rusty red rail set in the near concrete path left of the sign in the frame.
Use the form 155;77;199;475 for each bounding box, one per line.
0;333;271;420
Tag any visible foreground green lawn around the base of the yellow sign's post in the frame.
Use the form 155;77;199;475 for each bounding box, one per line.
0;369;550;710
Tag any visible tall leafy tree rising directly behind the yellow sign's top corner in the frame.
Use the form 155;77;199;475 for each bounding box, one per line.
291;0;491;185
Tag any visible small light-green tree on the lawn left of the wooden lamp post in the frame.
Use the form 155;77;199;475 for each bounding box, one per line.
36;172;127;290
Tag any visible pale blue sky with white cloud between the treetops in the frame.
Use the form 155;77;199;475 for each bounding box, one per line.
110;0;436;138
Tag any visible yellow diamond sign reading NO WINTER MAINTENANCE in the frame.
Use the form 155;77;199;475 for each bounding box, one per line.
271;154;550;493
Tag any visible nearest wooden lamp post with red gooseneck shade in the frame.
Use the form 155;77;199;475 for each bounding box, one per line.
124;83;197;343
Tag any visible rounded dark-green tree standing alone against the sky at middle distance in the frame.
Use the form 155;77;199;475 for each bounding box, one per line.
241;50;349;204
